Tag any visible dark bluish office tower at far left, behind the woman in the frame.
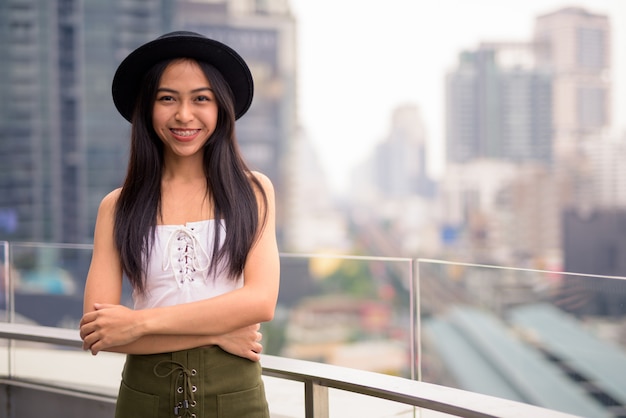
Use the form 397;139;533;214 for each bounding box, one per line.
0;0;171;243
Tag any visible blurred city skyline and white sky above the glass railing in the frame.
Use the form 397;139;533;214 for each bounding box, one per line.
0;0;626;275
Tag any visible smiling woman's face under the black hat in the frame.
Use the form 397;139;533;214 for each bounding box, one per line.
152;59;218;161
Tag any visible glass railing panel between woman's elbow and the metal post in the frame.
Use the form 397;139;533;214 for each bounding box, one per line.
262;254;415;378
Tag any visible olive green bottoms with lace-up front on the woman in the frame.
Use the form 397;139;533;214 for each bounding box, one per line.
115;346;269;418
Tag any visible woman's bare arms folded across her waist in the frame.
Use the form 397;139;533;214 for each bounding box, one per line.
81;173;279;354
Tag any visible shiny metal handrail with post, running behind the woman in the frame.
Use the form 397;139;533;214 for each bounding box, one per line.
0;323;575;418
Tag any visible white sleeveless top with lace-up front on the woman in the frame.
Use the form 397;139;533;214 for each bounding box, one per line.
133;219;243;309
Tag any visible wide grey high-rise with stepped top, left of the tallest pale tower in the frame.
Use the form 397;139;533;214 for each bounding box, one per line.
446;43;552;163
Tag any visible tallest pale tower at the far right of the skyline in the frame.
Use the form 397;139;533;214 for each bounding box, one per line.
534;7;611;155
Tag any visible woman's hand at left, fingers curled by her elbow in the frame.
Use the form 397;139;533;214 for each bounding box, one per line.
80;303;142;356
